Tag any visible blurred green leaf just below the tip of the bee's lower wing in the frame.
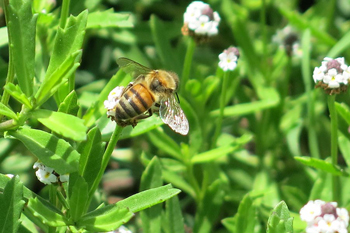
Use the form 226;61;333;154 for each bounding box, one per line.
147;129;182;160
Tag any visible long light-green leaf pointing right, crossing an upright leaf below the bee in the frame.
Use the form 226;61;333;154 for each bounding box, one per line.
118;184;181;213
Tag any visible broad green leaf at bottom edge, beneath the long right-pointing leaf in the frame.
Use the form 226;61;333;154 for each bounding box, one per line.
75;203;134;232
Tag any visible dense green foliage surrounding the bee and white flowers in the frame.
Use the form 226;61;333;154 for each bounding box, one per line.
0;0;350;233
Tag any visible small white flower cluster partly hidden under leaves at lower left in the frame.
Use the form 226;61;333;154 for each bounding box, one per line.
33;161;69;184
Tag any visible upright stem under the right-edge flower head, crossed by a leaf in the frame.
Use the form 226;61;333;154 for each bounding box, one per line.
328;95;340;202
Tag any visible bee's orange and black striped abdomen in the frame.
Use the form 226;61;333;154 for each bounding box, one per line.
116;83;154;120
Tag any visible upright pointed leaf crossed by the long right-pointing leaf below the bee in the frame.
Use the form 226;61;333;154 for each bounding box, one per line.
140;156;163;233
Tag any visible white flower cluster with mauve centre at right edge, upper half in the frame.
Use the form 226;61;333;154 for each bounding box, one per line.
313;57;350;95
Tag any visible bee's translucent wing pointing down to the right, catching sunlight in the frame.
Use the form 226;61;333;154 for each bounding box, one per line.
159;95;189;135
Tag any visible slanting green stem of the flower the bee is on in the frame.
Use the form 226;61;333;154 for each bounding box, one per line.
87;125;123;206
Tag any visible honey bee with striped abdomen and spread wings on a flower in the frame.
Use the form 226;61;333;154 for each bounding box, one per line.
115;58;189;135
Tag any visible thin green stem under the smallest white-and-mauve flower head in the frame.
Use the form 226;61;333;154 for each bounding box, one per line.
211;71;230;148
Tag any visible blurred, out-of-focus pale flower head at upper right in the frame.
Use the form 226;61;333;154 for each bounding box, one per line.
272;26;303;57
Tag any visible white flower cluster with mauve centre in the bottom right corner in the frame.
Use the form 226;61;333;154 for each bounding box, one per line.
300;200;349;233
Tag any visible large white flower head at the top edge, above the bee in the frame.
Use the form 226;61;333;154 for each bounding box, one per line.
181;1;221;42
